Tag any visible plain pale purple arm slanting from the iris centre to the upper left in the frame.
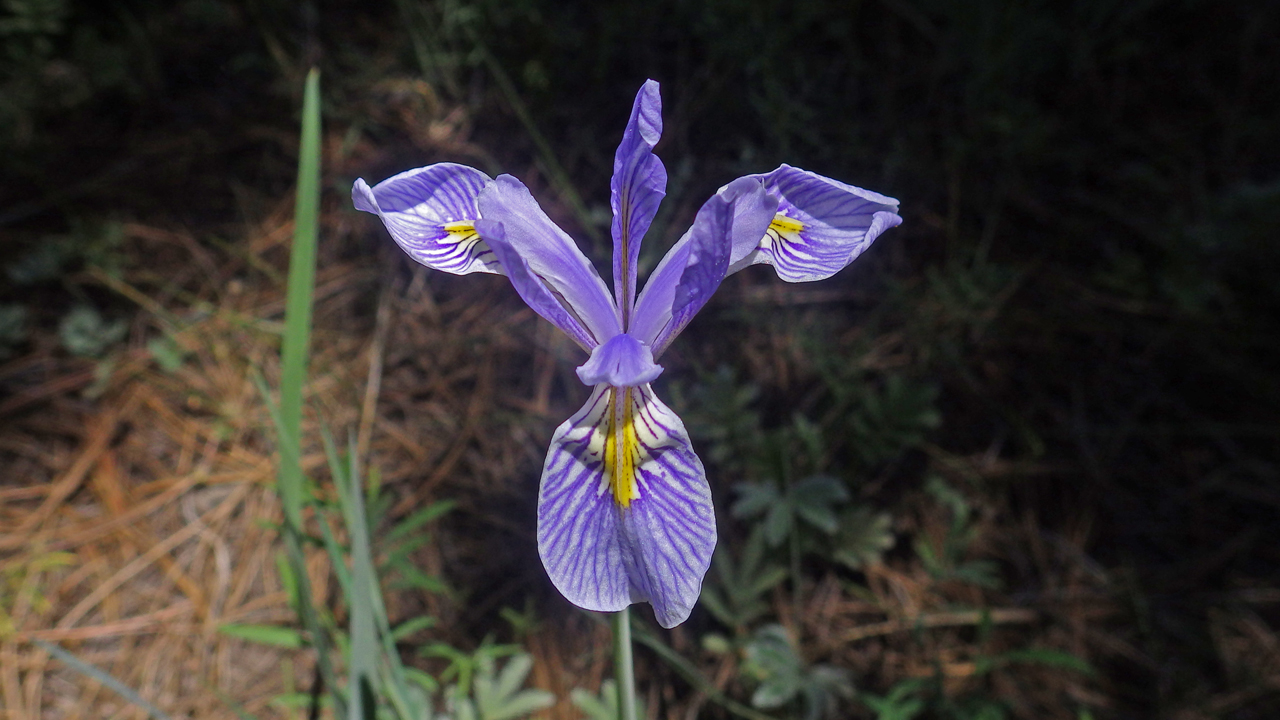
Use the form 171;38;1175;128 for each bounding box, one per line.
477;176;622;347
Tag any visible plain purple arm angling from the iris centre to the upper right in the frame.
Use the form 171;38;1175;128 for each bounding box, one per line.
631;178;777;357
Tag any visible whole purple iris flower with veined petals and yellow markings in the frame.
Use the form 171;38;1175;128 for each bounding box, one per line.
352;79;902;628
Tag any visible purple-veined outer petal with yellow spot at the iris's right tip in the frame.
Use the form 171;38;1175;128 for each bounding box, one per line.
730;165;902;282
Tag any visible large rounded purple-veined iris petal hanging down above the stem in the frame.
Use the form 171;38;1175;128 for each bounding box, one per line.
538;386;716;628
